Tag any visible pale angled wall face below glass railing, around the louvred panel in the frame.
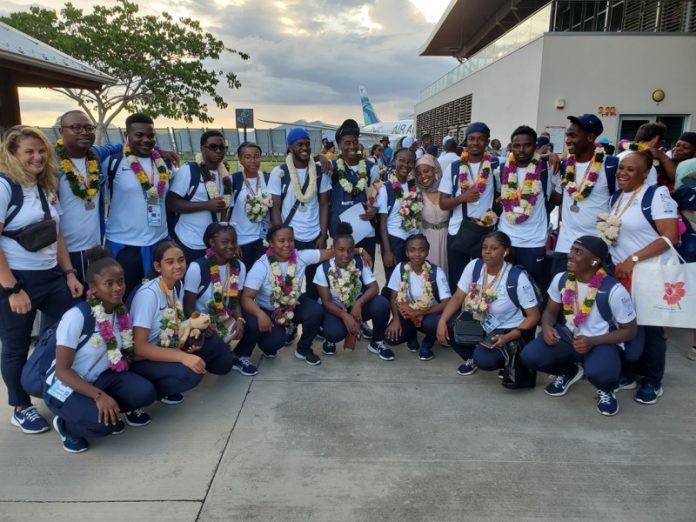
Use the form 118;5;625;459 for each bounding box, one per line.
416;38;543;146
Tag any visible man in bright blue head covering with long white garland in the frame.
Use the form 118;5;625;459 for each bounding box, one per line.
268;128;331;299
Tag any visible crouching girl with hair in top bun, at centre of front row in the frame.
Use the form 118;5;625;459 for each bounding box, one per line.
314;219;393;360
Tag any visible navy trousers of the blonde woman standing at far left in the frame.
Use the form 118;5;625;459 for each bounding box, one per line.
0;267;77;406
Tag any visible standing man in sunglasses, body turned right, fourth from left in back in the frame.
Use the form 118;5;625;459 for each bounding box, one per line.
167;130;231;263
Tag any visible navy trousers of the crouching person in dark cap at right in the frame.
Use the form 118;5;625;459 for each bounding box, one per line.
521;335;622;392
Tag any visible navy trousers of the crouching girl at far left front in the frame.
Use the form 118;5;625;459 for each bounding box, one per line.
44;370;156;437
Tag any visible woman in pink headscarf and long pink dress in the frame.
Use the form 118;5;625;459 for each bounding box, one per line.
416;154;450;274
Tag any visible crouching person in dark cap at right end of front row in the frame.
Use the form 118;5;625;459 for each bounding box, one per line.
521;236;637;415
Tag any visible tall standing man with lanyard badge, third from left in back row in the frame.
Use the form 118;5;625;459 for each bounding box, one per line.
106;112;170;295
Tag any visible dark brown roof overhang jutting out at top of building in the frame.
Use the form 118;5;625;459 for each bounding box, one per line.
420;0;550;58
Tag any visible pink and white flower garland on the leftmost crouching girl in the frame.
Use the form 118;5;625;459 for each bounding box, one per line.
87;290;133;372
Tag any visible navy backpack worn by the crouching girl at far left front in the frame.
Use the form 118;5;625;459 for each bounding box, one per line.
21;301;96;398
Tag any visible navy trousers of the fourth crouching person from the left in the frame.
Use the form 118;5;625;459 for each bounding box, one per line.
237;294;324;355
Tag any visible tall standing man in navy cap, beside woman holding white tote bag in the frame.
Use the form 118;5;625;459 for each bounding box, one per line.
551;114;619;274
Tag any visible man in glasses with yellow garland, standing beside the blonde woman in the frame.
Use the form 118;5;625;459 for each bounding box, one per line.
56;111;123;284
